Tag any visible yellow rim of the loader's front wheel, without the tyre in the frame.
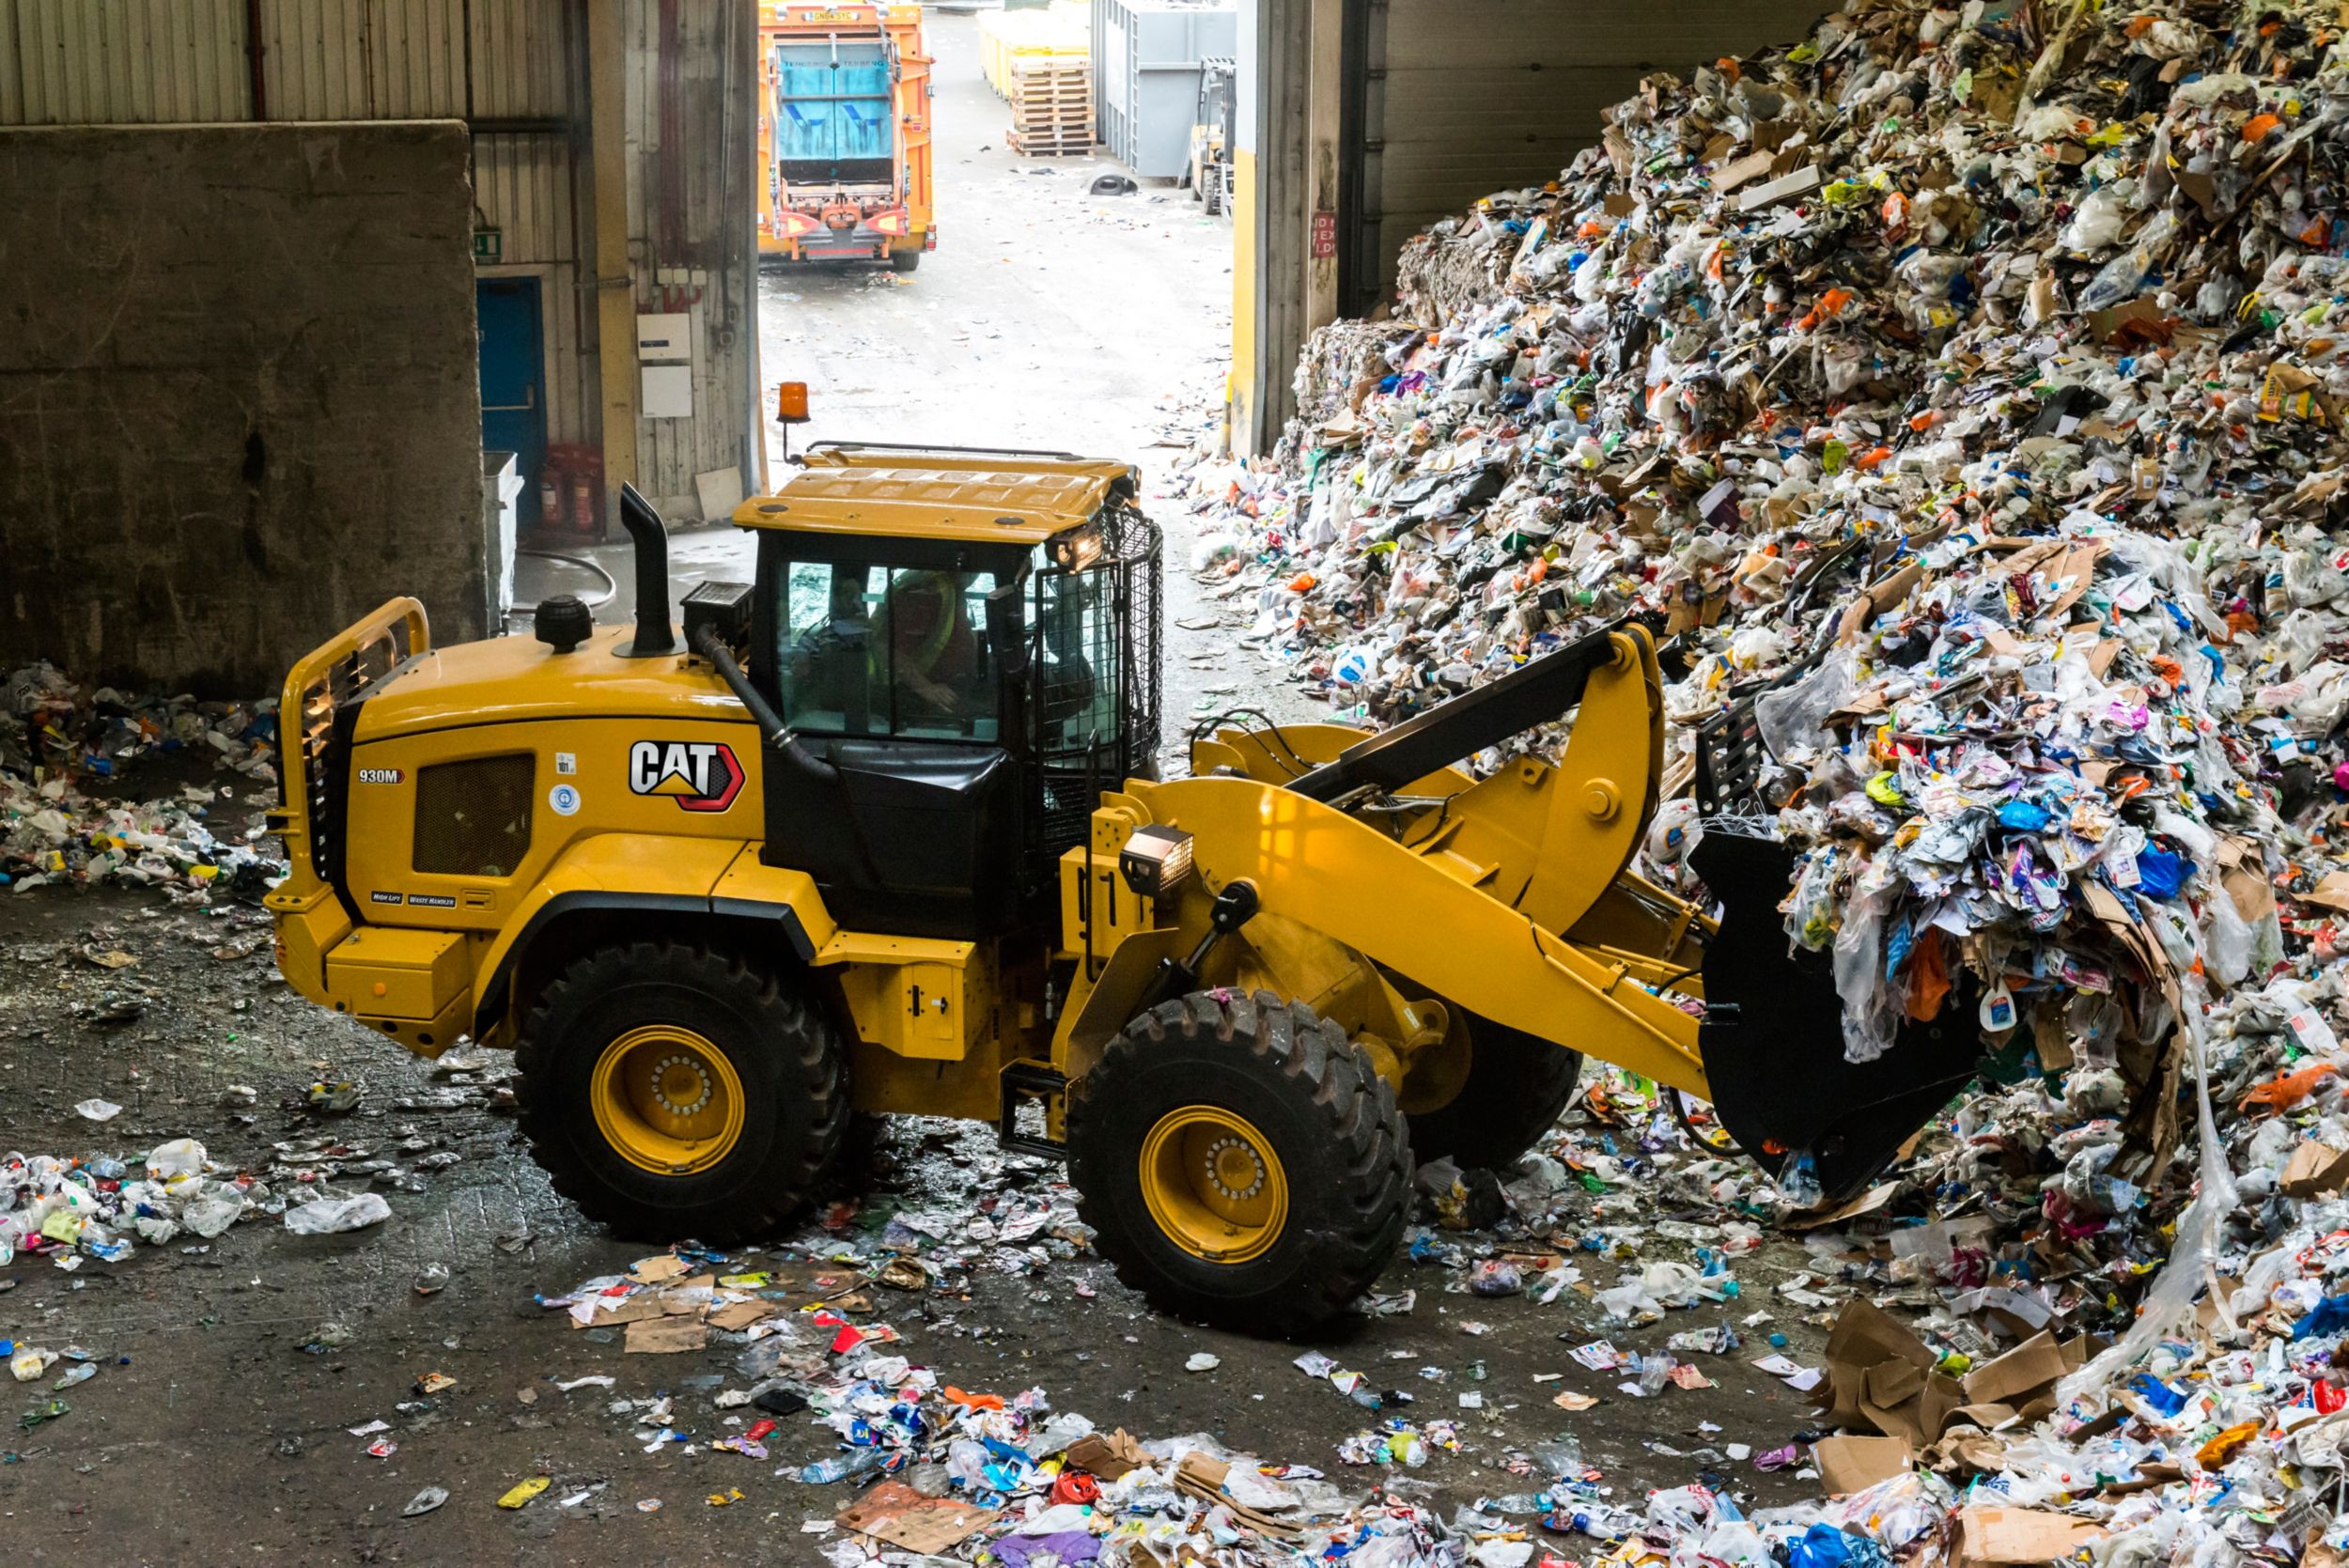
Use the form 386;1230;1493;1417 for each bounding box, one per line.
1142;1106;1290;1263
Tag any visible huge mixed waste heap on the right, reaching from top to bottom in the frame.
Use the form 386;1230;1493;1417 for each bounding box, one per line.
1170;0;2349;1563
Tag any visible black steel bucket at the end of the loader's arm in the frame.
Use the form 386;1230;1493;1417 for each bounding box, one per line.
1689;821;1983;1204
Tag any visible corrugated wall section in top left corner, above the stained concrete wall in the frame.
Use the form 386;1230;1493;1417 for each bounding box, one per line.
0;0;252;124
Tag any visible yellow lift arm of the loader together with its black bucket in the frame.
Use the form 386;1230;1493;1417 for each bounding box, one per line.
1099;625;1981;1202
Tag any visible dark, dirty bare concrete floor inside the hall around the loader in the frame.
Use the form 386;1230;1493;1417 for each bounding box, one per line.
0;877;1823;1568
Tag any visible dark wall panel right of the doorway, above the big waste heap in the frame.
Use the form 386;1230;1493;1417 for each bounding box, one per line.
1362;0;1830;298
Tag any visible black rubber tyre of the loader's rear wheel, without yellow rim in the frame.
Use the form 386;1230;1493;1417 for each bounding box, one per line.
515;941;848;1244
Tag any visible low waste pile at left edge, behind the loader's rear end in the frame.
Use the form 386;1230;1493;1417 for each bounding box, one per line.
0;664;280;899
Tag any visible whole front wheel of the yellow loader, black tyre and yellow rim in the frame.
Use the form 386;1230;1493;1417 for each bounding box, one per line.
1069;990;1412;1333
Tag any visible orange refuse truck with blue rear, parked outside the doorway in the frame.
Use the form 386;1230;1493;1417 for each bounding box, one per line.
759;0;938;272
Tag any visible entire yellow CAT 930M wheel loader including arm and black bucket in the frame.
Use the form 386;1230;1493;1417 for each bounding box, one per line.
271;443;1978;1331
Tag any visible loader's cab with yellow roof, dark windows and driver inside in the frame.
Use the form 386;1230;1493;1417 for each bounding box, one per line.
736;443;1159;941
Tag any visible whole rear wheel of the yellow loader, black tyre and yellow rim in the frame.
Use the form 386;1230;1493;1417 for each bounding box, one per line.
515;941;848;1244
